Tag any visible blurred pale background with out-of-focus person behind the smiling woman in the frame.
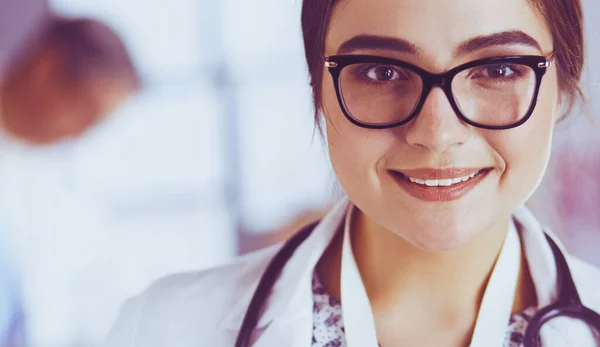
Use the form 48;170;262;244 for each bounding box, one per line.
0;0;600;347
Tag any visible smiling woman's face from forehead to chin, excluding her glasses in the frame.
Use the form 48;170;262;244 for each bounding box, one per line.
322;0;559;250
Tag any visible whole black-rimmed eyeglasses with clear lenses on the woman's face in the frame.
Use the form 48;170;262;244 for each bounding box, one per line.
325;54;553;130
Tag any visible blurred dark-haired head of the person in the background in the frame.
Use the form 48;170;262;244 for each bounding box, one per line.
0;16;139;145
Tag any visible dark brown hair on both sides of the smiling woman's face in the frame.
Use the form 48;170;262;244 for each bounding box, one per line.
302;0;584;130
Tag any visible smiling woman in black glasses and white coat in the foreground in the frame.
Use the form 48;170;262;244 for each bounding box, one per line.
108;0;600;347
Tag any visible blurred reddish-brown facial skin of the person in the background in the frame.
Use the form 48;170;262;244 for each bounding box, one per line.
0;49;134;145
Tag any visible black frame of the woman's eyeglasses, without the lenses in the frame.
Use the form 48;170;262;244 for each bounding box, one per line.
325;53;554;130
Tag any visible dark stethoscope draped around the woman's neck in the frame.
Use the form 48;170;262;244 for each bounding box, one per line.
235;222;600;347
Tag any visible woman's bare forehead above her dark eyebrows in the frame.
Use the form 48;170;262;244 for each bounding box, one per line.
325;0;552;59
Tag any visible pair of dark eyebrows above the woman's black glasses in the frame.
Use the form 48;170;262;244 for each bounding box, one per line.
337;30;542;56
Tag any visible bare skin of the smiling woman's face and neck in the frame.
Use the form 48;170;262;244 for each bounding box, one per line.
318;0;560;346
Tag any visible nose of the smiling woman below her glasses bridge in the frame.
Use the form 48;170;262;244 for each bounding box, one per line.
404;88;472;153
